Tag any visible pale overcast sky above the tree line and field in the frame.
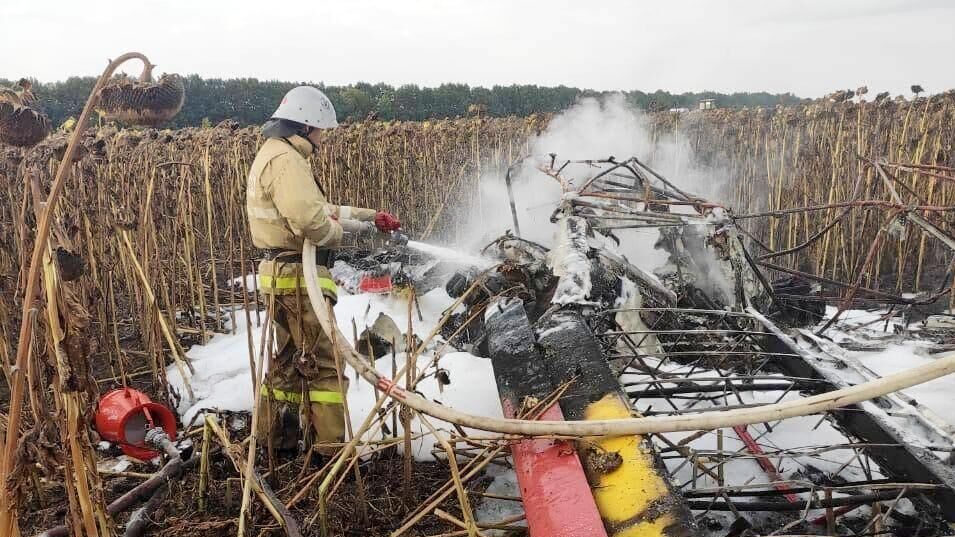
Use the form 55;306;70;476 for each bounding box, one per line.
0;0;955;97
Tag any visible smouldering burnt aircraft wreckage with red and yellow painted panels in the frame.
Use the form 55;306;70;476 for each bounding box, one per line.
326;155;955;537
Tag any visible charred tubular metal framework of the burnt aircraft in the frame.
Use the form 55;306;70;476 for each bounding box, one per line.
486;155;955;530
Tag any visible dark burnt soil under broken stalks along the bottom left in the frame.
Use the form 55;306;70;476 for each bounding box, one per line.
20;445;487;537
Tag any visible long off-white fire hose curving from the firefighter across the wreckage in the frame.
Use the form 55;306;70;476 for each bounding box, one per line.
302;240;955;437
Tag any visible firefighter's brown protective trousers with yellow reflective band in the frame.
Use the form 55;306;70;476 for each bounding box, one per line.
258;265;348;454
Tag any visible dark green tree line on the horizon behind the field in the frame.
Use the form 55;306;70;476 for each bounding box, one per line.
0;75;801;127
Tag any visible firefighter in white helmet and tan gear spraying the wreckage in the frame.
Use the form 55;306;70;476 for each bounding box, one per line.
246;86;401;454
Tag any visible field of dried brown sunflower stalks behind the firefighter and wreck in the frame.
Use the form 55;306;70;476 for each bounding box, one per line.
0;93;955;527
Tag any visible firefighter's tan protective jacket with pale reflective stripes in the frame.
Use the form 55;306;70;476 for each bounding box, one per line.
246;136;377;294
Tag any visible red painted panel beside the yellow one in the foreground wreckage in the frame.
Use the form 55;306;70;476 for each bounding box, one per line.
502;400;607;537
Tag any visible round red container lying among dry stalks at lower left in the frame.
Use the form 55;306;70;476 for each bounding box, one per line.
96;388;176;460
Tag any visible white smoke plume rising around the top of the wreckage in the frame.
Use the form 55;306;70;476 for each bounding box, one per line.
470;94;727;271
